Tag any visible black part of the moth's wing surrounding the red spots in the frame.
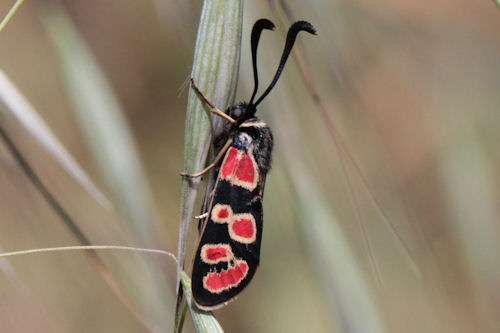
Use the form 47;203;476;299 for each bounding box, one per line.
192;118;273;310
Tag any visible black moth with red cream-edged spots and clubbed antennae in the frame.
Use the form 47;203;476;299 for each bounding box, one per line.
182;19;316;310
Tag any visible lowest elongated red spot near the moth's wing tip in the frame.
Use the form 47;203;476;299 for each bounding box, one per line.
204;260;248;293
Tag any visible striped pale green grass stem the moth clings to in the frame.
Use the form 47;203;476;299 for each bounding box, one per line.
177;0;243;283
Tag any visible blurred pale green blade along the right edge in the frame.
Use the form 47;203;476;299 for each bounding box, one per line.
440;130;500;332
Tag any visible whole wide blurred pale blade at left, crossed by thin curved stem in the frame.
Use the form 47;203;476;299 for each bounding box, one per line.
39;5;175;330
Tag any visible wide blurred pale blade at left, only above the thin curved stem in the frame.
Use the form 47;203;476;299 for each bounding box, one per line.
43;6;156;244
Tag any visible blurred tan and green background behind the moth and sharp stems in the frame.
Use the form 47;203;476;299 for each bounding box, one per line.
0;0;500;332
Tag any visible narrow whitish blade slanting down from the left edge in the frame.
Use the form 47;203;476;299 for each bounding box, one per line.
0;70;112;209
